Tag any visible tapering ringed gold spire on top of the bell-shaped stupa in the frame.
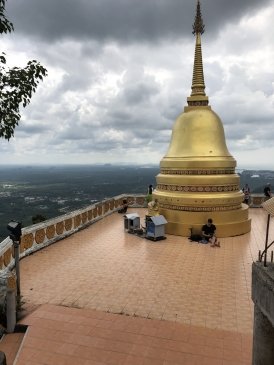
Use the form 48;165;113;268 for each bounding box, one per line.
187;0;208;106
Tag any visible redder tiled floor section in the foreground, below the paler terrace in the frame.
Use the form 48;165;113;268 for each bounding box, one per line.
15;304;251;365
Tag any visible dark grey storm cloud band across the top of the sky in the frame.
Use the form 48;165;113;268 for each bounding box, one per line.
7;0;271;43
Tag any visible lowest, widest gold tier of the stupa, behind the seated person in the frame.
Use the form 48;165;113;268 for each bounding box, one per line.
160;204;251;237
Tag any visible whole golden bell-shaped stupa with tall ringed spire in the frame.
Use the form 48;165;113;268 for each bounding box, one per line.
153;0;251;237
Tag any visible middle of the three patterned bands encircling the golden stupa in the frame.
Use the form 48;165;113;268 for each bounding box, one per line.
157;184;240;193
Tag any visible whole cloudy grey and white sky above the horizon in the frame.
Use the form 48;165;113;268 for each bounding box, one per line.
0;0;274;169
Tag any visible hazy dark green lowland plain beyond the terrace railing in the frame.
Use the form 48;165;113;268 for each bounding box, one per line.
0;165;274;241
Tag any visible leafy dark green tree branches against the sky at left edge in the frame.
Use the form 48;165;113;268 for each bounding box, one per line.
0;0;47;140
